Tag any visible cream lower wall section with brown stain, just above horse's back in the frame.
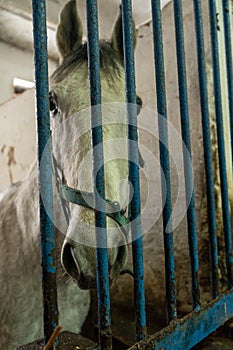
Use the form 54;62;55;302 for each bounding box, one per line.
0;89;36;191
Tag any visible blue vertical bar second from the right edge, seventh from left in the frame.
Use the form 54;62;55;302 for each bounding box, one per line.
209;0;233;289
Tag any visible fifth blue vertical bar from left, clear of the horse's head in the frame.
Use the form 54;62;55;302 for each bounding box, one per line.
174;0;200;309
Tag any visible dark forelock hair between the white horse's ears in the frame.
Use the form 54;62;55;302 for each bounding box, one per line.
51;40;123;83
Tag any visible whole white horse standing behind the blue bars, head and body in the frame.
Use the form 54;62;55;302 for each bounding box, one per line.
0;0;135;350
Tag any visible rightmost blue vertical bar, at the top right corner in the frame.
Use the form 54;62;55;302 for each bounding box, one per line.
222;0;233;163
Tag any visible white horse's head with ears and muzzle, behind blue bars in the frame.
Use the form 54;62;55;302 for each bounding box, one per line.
50;0;136;289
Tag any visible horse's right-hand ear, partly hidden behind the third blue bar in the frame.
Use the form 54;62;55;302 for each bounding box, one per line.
111;6;137;60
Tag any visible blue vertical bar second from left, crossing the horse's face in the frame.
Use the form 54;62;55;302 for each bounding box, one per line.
86;0;112;349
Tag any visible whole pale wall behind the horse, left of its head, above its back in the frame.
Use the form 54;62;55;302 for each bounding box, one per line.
0;41;56;191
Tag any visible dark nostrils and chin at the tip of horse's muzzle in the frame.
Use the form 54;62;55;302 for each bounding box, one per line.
62;243;127;290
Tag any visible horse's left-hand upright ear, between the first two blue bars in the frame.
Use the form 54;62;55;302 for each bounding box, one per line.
56;0;83;57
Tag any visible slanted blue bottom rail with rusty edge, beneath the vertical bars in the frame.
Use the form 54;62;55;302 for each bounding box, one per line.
128;292;233;350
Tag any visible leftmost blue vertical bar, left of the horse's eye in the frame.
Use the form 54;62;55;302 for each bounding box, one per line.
32;0;58;343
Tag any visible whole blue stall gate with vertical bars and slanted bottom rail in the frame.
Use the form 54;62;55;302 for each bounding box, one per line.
32;0;233;350
